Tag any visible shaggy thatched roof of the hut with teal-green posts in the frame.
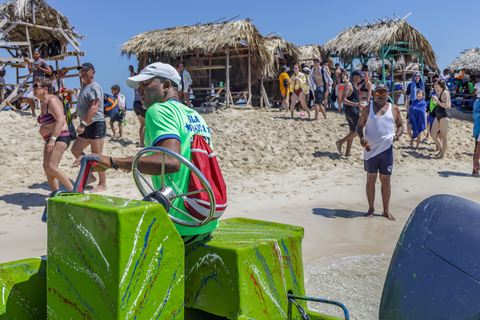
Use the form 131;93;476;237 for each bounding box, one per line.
323;19;438;69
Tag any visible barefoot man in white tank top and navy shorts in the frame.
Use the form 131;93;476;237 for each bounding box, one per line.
357;84;403;220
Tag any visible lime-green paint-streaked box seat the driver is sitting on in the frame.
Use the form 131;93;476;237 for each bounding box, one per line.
185;218;342;320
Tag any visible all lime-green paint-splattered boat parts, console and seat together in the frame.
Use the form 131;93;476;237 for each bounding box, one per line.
0;195;344;320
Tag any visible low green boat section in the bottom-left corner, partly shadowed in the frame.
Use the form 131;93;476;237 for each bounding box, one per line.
0;257;47;320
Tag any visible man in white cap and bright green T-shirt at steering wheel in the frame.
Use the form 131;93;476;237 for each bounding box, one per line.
74;62;218;244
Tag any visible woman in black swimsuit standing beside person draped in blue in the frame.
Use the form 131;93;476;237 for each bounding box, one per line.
432;80;452;159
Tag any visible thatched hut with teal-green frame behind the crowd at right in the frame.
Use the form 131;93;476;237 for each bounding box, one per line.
323;16;438;101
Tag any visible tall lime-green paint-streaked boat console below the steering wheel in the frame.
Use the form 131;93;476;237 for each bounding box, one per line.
47;195;184;320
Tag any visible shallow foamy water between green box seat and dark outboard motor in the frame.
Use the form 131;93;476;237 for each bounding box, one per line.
306;254;391;320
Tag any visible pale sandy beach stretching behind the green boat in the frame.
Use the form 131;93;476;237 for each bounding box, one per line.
0;105;480;319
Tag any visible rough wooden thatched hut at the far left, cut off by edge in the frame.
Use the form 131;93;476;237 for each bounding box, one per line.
0;0;85;110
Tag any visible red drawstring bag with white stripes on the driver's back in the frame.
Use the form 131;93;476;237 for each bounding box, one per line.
184;134;227;220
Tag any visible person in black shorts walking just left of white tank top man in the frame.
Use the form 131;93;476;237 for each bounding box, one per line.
336;70;365;157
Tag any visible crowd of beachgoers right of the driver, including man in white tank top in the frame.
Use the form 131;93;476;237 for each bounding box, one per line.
279;58;480;220
